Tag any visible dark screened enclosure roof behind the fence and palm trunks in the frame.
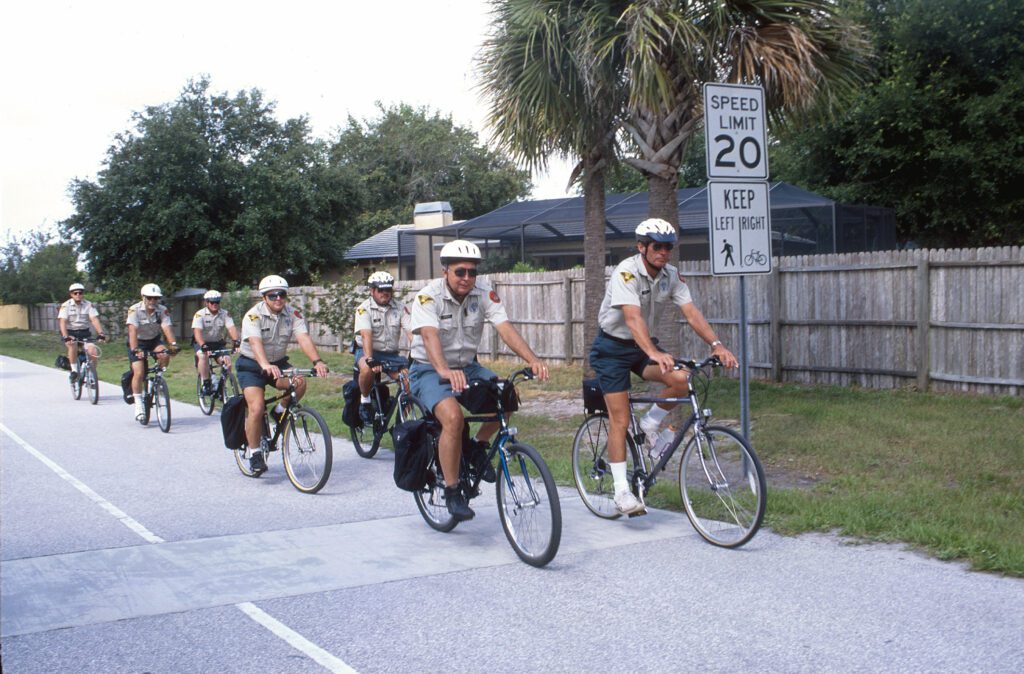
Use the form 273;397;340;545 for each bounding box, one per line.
402;182;835;239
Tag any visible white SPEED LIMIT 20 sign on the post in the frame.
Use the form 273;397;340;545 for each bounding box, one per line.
703;82;768;180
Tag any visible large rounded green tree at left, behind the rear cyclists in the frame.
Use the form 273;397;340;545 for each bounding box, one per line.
62;79;360;288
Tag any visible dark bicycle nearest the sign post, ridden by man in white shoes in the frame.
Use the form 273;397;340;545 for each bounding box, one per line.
572;355;767;548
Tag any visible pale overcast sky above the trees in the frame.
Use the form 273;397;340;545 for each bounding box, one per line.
0;0;568;244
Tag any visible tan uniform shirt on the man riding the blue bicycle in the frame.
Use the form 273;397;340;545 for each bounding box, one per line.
410;278;509;368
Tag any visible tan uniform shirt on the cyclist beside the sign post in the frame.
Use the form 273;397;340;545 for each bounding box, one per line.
597;254;693;339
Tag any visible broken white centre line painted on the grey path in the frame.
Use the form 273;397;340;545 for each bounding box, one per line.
0;423;355;674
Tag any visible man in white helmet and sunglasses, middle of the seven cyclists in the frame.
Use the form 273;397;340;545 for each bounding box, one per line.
234;276;329;477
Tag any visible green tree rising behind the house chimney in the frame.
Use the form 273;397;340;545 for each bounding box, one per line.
331;102;530;244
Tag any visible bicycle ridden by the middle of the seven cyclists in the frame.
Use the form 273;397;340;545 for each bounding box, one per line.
232;368;334;494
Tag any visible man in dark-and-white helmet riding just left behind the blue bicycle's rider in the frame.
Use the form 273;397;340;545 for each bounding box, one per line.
355;271;410;424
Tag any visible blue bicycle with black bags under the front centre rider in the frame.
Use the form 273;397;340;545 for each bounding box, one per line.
398;368;562;566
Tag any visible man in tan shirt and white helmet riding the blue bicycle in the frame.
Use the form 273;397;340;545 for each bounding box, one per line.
409;241;548;520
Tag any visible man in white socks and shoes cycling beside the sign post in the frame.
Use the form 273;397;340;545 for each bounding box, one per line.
590;218;737;514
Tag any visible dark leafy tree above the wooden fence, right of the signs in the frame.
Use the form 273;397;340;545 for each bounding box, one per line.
771;0;1024;247
